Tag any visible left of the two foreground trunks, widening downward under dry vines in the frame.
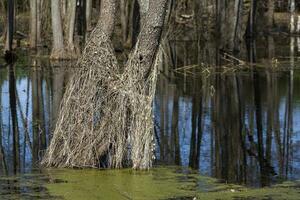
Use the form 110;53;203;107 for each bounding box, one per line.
42;0;118;167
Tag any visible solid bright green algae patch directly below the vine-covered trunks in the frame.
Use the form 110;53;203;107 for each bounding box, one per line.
47;169;196;200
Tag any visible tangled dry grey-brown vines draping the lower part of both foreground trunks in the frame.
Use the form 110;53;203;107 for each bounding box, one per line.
42;24;157;169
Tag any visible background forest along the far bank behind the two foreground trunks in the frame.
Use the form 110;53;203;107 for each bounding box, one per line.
0;0;300;59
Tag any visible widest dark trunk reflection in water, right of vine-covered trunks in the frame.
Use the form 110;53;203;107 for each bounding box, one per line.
212;65;247;183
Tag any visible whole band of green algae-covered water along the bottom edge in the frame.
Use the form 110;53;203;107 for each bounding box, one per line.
0;168;300;200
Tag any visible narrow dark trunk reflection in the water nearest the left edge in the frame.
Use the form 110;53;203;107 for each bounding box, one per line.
9;65;20;173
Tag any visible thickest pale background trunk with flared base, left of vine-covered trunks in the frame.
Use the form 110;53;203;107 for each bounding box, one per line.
50;0;65;59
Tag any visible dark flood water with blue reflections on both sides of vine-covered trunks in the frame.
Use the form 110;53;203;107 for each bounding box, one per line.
0;37;300;199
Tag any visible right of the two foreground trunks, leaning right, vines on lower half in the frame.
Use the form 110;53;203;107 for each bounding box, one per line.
118;0;167;169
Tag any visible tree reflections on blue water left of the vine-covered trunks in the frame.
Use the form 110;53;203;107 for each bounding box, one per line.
0;58;69;173
